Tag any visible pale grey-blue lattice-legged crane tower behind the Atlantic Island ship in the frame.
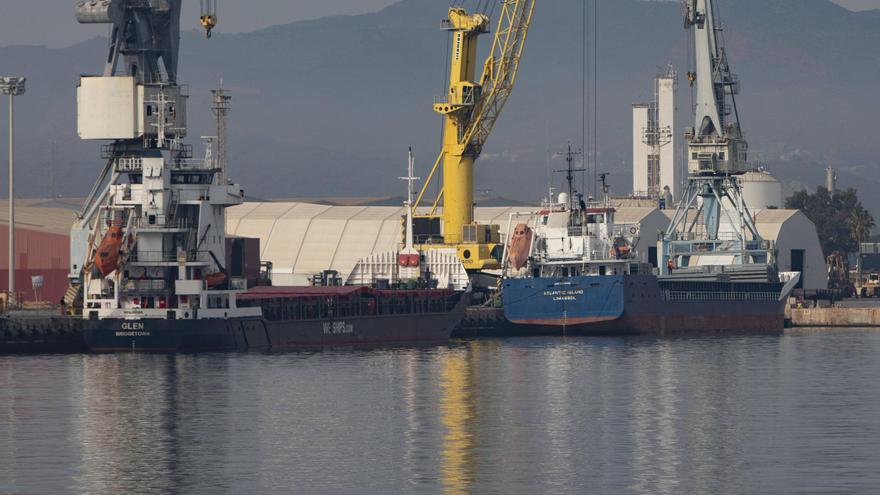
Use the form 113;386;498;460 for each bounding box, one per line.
660;0;772;274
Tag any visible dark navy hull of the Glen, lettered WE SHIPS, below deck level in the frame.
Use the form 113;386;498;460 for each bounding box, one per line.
83;301;465;353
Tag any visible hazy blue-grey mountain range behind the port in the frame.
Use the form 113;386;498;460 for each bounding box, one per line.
0;0;880;214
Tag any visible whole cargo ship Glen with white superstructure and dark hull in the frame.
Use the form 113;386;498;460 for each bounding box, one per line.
82;138;469;352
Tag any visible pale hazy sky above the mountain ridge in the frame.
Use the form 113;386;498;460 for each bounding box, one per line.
0;0;880;47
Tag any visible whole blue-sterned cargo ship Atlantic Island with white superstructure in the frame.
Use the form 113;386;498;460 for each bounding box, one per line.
502;188;799;335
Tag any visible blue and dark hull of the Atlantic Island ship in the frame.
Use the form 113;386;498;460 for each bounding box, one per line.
503;275;785;335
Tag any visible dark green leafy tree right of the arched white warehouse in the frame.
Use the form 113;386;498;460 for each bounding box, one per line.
785;187;874;256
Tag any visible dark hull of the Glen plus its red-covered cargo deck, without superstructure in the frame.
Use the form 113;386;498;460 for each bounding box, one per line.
83;286;468;353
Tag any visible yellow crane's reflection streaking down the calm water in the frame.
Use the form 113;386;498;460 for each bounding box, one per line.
440;351;473;494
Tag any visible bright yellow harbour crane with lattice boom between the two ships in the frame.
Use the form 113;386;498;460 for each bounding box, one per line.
415;0;536;271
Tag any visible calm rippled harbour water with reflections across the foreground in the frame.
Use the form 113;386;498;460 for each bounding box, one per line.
0;331;880;494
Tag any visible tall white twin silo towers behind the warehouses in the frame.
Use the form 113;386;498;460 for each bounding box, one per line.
633;68;681;202
